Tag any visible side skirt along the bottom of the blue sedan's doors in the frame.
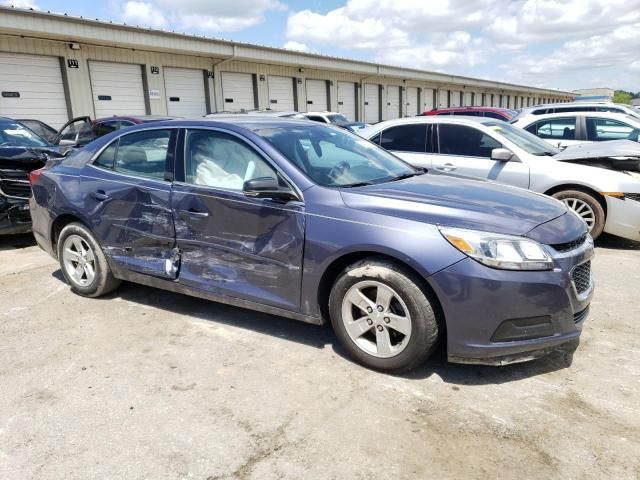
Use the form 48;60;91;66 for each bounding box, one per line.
114;269;324;325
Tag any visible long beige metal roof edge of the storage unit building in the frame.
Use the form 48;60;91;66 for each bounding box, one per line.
0;6;575;97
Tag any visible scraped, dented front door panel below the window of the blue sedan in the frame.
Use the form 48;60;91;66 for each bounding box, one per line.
172;183;305;311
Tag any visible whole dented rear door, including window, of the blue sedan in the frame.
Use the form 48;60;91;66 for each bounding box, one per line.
81;128;178;278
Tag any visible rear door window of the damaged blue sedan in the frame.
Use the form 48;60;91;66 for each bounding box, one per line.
114;130;171;180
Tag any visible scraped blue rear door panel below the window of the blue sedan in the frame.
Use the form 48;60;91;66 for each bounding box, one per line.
81;166;178;278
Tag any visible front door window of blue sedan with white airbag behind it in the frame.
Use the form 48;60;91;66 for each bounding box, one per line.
185;130;281;191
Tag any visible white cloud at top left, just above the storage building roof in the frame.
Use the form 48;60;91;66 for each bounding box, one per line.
121;0;286;31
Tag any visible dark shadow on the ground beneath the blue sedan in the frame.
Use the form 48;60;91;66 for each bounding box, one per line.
52;270;569;385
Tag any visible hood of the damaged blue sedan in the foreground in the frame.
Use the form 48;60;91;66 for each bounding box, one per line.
341;172;568;243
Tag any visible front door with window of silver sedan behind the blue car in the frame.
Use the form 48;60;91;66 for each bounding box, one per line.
433;123;529;188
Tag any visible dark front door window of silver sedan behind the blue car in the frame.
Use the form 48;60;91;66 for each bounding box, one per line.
438;124;502;158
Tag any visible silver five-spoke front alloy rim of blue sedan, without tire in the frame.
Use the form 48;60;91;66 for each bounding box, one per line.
342;280;411;358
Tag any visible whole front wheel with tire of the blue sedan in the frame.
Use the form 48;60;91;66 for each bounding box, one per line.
329;258;440;372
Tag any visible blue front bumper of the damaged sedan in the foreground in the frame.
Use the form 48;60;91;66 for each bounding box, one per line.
430;238;593;365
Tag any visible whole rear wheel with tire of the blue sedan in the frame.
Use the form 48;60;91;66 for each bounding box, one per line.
57;222;120;297
